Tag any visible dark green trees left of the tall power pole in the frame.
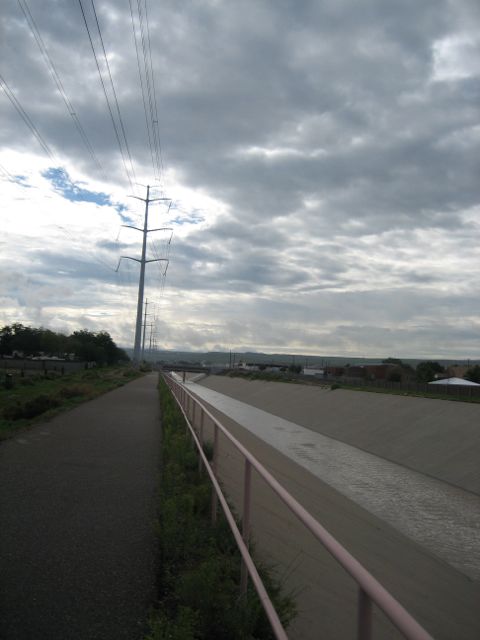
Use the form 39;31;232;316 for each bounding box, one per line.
0;323;129;365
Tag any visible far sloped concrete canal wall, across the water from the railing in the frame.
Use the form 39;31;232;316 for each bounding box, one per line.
200;376;480;495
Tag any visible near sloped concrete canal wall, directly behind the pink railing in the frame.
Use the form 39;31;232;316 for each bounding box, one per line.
191;380;480;640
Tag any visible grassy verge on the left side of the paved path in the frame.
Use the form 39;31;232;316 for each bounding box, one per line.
0;367;142;440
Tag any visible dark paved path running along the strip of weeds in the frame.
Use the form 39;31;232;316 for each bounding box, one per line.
0;374;160;640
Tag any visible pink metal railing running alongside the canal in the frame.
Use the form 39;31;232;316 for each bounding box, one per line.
163;375;433;640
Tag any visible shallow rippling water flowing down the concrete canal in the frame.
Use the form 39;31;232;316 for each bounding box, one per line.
188;383;480;580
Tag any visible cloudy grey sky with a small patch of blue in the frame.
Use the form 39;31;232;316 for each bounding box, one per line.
0;0;480;360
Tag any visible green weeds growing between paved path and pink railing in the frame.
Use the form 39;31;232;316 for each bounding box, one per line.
148;381;294;640
